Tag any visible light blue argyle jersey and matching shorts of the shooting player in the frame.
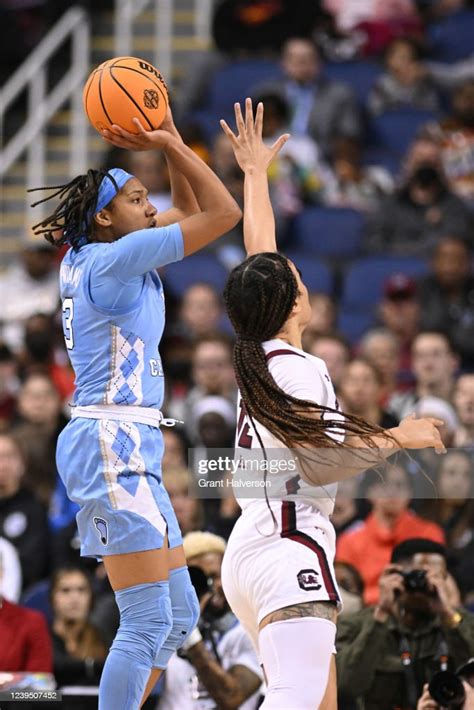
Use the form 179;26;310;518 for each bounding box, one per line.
57;224;184;557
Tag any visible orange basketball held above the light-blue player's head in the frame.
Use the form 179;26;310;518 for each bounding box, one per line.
82;57;168;133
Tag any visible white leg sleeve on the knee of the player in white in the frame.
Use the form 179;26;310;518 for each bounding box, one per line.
258;617;336;710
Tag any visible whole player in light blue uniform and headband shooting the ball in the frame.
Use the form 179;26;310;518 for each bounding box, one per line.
30;108;241;710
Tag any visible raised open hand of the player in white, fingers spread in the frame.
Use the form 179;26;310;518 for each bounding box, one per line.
220;99;290;172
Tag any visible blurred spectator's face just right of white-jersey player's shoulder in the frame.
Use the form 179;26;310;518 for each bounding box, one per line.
338;358;399;429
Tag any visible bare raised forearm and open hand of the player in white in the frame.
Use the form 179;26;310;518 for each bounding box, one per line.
221;99;290;256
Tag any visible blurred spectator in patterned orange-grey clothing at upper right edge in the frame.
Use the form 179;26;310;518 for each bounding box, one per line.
439;78;474;204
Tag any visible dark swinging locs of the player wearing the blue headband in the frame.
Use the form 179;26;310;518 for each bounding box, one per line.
28;170;119;251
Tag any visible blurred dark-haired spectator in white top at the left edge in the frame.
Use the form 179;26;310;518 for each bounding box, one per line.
0;246;59;352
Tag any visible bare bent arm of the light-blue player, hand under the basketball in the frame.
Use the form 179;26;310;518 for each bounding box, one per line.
103;118;242;256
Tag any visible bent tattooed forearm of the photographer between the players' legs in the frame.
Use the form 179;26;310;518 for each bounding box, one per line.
186;641;261;710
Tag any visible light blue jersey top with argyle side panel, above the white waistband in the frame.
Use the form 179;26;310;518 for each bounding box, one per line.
60;224;183;409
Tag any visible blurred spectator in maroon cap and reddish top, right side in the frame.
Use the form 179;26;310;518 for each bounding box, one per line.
377;274;420;386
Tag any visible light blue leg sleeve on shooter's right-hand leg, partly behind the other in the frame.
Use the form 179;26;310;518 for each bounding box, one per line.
153;567;200;668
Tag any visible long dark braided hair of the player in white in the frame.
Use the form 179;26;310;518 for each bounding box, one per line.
224;252;390;458
